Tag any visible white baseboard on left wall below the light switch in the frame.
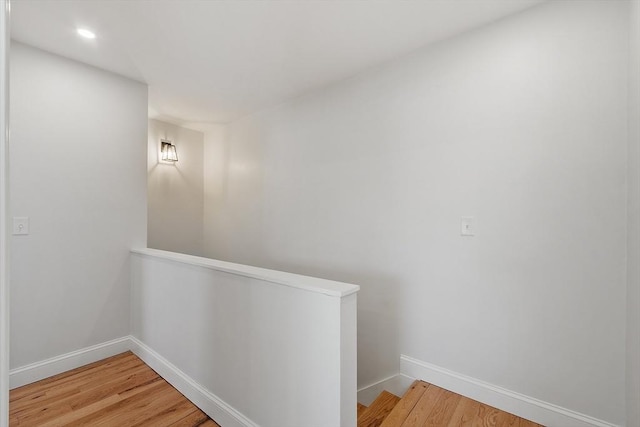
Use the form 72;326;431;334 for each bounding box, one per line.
9;337;131;389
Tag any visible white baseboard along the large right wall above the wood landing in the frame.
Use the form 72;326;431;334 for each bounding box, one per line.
400;355;619;427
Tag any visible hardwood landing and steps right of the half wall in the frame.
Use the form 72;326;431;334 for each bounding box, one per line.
358;381;541;427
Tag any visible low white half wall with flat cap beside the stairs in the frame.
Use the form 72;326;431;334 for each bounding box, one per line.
132;249;358;427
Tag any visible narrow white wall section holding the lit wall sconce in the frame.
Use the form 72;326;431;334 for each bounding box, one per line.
147;120;204;255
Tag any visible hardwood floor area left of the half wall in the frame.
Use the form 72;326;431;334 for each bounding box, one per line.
9;352;220;427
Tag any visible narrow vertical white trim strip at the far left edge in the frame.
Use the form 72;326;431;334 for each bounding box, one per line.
0;0;10;426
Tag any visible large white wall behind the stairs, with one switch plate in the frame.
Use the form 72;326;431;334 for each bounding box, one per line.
205;1;628;424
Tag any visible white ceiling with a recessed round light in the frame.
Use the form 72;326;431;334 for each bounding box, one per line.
11;0;542;127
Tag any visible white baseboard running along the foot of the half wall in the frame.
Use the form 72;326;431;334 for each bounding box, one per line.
129;336;258;427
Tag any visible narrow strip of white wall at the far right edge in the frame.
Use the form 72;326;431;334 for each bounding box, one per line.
627;0;640;426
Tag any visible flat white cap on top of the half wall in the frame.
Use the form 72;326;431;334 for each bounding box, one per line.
131;248;360;298
